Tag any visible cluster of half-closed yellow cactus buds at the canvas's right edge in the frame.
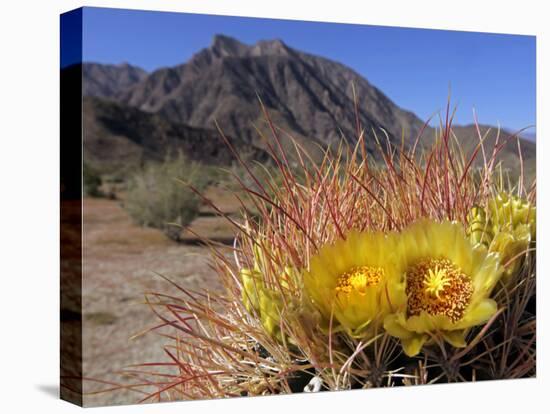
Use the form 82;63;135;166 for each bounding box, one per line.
468;193;536;279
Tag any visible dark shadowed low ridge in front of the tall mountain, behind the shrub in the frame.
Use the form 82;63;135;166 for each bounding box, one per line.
83;97;267;173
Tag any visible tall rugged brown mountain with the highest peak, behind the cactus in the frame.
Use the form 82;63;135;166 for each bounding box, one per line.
116;35;422;155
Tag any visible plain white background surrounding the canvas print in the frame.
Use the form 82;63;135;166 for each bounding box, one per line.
0;0;550;413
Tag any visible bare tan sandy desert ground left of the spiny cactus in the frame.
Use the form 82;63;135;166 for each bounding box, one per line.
82;198;232;406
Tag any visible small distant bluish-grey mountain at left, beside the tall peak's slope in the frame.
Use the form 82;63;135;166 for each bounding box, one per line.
82;63;147;98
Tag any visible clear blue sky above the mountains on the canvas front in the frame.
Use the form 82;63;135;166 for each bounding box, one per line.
71;8;536;131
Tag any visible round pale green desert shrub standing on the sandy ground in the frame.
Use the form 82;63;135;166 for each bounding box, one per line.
124;153;211;241
